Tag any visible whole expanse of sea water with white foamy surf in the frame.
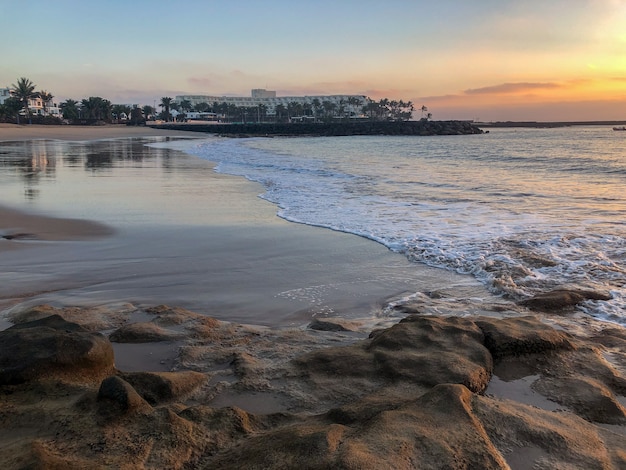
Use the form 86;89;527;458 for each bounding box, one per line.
179;126;626;324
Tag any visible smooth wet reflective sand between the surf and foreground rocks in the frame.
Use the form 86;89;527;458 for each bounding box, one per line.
0;128;488;327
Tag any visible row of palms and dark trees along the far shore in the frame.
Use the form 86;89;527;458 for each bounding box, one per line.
0;77;424;124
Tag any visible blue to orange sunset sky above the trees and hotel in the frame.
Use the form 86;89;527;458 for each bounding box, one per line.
0;0;626;121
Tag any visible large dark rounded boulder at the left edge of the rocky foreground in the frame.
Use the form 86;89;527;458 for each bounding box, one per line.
0;315;114;385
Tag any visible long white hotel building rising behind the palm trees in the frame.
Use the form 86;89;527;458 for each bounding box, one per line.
174;88;367;116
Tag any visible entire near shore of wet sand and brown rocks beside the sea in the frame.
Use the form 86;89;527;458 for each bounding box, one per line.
0;125;626;469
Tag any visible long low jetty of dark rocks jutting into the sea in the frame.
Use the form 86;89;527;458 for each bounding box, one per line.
150;120;483;137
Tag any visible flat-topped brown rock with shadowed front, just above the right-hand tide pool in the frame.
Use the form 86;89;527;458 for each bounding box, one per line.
476;317;575;359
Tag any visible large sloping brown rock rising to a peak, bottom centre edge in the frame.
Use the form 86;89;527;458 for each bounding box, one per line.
203;385;506;470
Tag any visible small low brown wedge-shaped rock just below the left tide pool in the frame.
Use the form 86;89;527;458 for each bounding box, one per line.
119;371;207;405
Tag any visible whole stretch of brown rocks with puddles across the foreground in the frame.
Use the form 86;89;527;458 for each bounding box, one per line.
0;294;626;469
